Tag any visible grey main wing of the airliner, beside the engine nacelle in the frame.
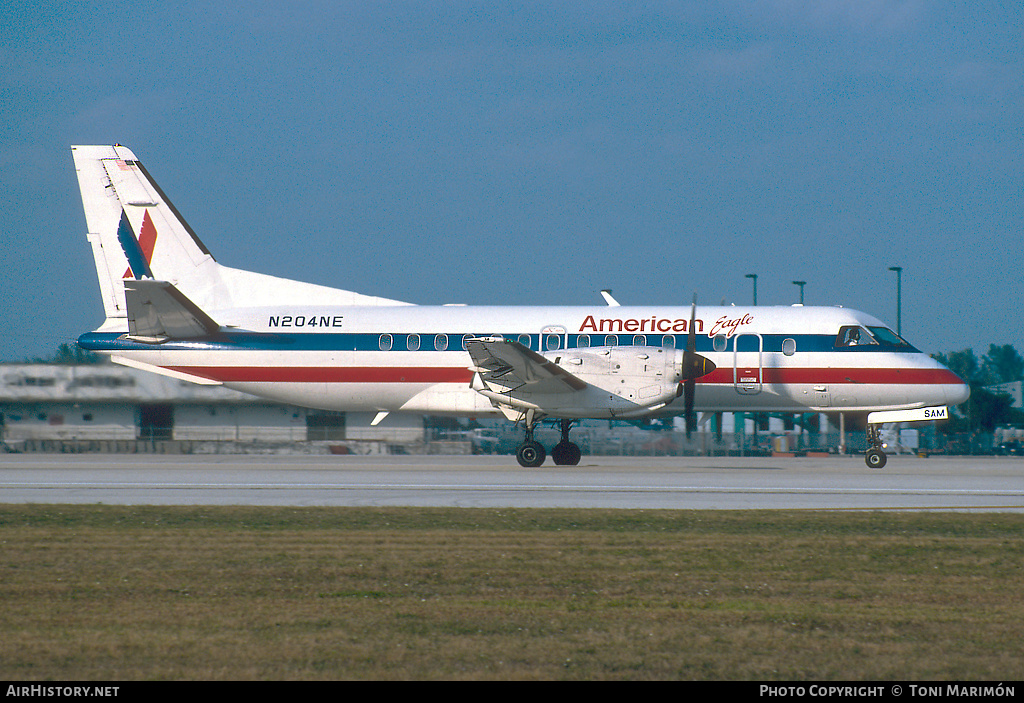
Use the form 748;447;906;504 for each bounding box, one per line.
466;337;587;394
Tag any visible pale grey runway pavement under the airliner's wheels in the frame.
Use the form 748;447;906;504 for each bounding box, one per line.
0;454;1024;512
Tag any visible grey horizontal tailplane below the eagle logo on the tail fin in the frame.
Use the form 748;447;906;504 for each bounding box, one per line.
124;278;220;343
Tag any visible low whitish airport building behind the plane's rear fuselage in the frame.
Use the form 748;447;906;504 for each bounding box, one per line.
0;363;424;453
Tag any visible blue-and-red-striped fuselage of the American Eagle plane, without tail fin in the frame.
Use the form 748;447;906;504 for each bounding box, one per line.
80;305;966;418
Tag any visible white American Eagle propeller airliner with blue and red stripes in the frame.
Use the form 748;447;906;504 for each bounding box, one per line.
72;145;969;468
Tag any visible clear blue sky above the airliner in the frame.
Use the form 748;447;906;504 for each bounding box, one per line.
0;0;1024;361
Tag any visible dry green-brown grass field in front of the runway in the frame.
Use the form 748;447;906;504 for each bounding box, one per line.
0;506;1024;680
